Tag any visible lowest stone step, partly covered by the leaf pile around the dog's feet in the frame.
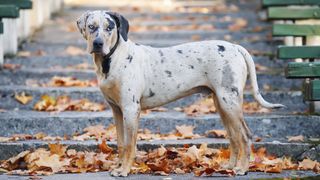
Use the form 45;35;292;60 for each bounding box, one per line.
0;138;315;160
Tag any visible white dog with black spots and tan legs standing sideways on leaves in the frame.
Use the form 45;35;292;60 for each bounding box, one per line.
77;11;283;176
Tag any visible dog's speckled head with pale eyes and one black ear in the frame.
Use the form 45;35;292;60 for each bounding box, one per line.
77;11;129;55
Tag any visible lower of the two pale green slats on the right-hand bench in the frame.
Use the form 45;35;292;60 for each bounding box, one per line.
272;24;320;36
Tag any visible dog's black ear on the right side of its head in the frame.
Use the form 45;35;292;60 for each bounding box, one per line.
106;11;129;41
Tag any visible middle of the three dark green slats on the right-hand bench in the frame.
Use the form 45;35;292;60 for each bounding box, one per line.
285;62;320;79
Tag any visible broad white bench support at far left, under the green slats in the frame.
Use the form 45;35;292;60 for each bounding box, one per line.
3;18;18;55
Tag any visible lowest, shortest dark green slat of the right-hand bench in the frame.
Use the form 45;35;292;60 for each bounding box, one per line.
303;80;320;101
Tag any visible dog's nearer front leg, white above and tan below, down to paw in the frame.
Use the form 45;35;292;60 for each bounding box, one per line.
111;104;140;176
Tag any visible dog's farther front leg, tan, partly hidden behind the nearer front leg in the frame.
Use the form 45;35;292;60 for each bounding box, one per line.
109;103;124;166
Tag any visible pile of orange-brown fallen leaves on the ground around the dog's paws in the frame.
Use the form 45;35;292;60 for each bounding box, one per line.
0;141;320;176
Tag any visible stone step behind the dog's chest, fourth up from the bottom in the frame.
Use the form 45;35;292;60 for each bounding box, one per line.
0;68;303;90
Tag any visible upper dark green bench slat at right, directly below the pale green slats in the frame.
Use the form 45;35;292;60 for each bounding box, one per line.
277;46;320;59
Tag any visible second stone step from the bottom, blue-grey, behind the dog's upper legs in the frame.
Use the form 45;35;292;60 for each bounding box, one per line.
0;110;320;140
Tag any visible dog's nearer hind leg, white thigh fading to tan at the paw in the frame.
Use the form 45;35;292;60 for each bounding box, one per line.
215;88;251;175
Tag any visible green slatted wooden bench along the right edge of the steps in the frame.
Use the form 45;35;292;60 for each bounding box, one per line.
262;0;320;112
